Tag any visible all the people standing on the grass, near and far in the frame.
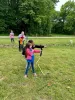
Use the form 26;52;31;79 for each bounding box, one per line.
10;30;45;78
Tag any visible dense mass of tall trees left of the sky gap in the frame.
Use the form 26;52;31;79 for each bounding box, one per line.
0;0;58;35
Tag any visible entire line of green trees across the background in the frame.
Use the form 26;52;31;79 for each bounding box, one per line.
0;0;75;36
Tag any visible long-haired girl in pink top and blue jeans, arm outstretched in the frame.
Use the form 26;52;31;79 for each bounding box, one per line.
24;43;41;78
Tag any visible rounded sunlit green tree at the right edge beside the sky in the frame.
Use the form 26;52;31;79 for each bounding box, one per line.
60;1;75;34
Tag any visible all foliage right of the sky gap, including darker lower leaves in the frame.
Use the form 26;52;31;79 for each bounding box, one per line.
53;1;75;34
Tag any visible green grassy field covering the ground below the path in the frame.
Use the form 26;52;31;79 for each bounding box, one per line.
0;38;75;100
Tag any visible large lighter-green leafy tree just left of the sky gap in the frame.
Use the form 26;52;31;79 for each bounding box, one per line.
19;0;57;35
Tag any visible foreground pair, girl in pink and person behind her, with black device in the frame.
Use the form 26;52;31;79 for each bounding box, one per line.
22;40;45;78
